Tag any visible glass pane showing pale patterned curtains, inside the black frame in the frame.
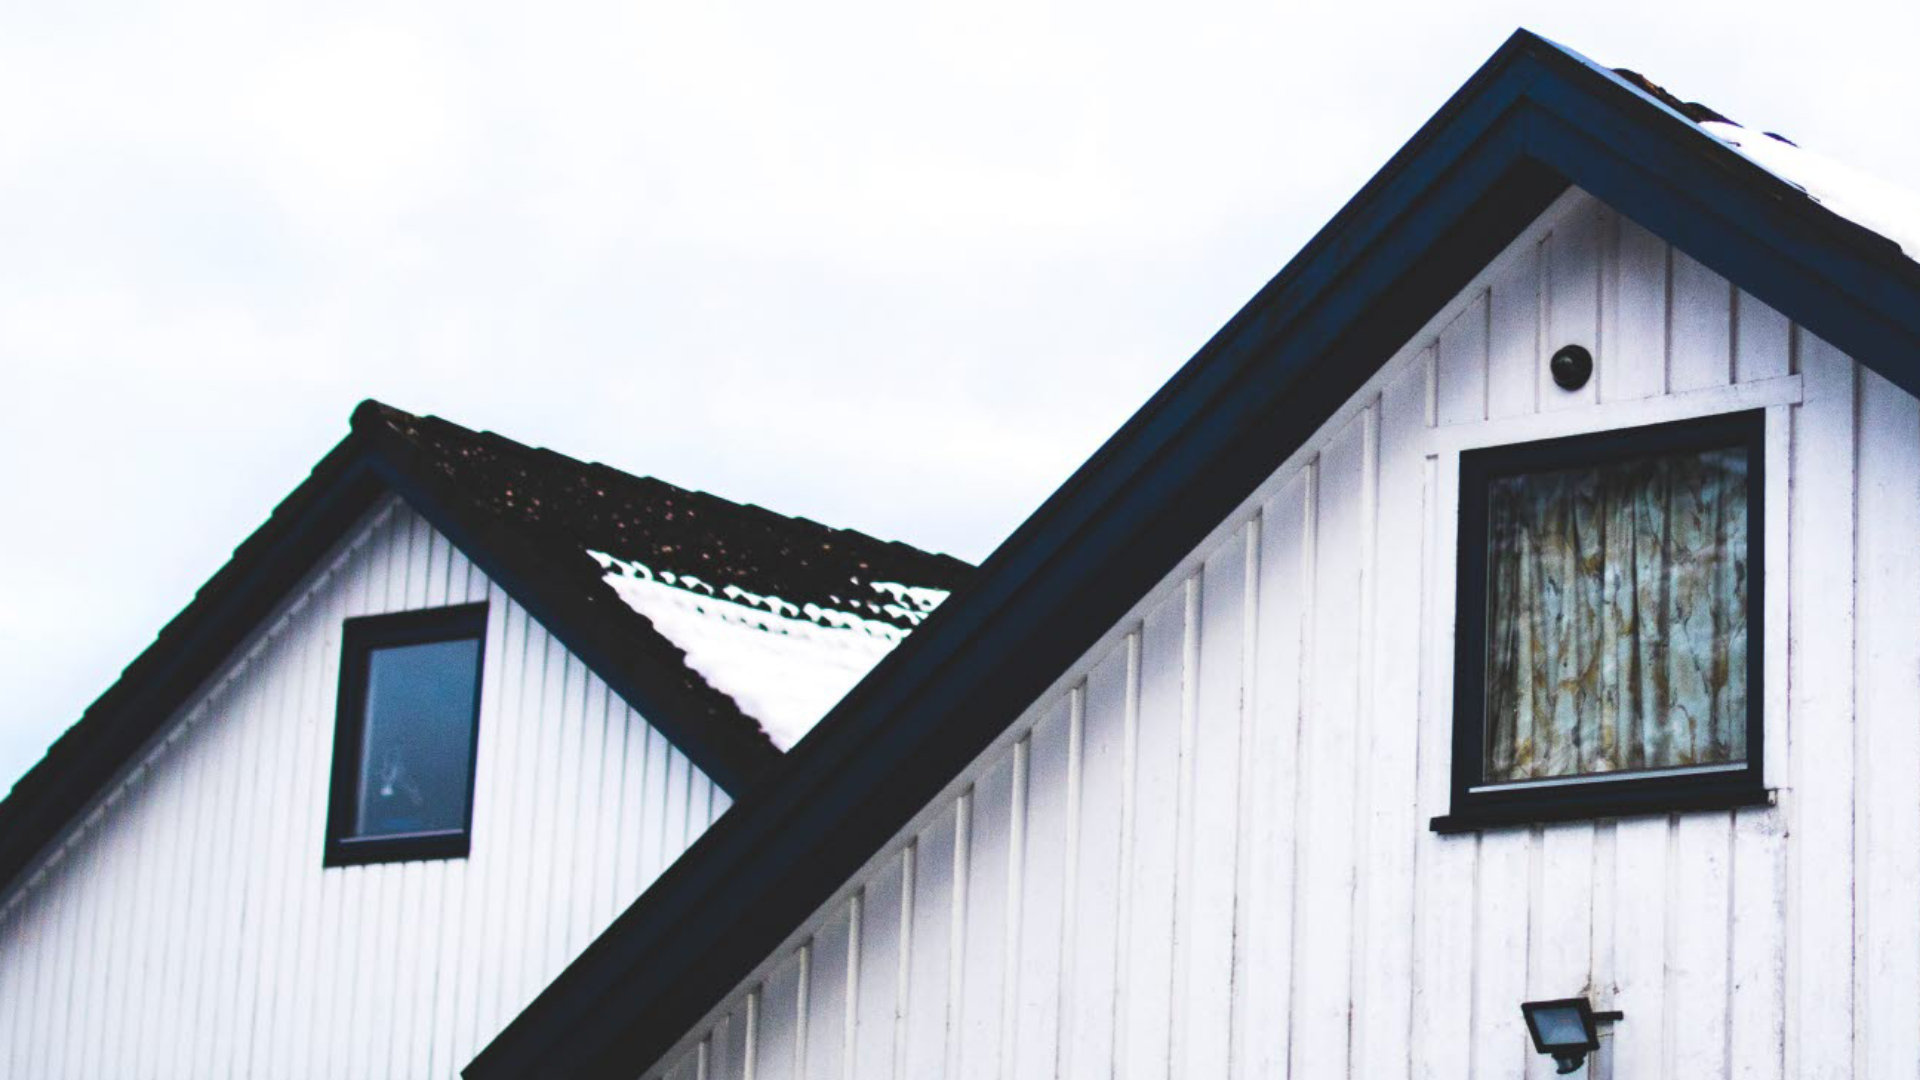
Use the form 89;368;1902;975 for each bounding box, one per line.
1486;441;1747;782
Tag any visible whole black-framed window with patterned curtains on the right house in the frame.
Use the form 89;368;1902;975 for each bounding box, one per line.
1432;413;1766;830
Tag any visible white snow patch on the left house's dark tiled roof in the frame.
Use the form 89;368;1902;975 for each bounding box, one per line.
588;550;947;749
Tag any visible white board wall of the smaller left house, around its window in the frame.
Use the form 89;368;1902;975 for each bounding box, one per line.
0;500;728;1080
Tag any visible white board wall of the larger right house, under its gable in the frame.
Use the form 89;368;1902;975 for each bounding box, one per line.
647;192;1920;1080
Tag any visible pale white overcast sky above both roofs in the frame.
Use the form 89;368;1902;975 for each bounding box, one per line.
0;0;1920;786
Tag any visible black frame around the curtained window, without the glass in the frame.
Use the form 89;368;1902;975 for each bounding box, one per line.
1430;409;1768;832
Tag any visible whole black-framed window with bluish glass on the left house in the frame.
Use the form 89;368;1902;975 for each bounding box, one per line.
326;603;486;867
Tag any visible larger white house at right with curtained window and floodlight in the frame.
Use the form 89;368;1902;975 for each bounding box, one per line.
465;31;1920;1080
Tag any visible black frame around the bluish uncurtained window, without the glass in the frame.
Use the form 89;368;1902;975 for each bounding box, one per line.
323;601;488;867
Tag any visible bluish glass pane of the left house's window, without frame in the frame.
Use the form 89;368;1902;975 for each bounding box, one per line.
353;638;480;836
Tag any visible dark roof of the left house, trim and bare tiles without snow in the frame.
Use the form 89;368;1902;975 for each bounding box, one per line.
0;400;970;888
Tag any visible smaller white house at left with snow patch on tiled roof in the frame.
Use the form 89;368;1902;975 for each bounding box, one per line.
0;402;968;1078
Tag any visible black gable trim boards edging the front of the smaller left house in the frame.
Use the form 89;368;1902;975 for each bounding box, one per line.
0;402;781;894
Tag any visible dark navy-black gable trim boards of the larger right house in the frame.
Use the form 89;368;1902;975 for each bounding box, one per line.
467;31;1920;1080
